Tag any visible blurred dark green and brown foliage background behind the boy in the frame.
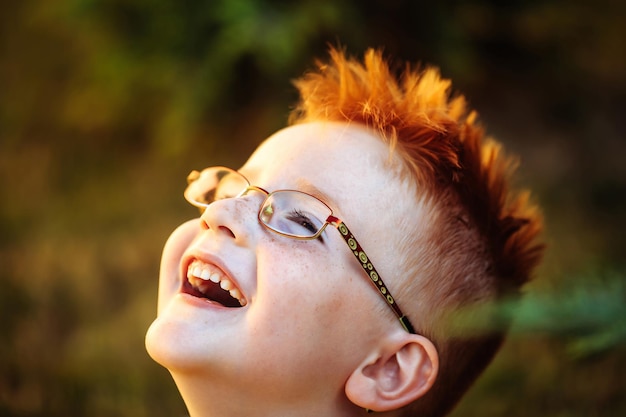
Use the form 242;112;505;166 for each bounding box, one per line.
0;0;626;417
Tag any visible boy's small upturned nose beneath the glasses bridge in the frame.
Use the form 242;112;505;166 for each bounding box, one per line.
200;195;260;245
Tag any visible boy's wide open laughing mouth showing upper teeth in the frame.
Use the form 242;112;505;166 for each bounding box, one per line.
182;259;248;307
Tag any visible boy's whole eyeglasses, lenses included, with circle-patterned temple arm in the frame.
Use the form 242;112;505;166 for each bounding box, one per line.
184;167;415;333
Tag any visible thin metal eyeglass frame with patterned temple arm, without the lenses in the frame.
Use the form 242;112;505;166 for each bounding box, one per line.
184;166;416;334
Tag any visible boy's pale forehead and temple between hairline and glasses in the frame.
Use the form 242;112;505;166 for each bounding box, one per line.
241;122;417;239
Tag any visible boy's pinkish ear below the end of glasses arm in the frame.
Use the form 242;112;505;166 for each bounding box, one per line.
345;333;439;411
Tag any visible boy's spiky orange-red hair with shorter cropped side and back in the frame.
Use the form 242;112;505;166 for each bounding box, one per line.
290;48;543;415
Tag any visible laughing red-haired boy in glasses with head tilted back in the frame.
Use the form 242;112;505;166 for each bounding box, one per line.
146;49;542;417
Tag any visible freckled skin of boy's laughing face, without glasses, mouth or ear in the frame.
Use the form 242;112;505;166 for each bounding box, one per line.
146;123;416;407
